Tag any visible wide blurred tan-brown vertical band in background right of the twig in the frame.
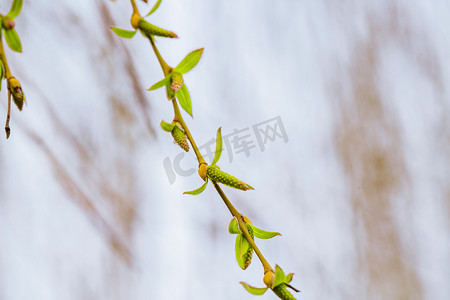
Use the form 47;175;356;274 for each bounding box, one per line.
328;3;450;299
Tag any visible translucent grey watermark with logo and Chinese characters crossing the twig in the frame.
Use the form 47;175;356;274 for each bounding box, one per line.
163;116;289;184
